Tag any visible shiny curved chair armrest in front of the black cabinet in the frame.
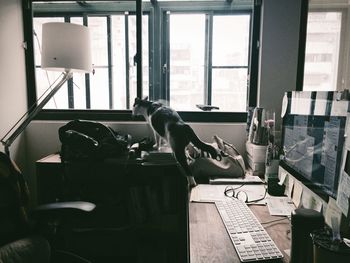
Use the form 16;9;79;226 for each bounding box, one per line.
32;201;96;221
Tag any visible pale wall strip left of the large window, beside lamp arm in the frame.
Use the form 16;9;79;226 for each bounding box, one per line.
0;0;27;167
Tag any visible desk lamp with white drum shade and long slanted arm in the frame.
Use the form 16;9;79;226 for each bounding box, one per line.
1;22;92;155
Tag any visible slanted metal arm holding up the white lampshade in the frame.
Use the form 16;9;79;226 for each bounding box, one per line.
1;71;73;155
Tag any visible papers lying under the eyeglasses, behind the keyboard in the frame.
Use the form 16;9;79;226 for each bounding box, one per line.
190;184;266;205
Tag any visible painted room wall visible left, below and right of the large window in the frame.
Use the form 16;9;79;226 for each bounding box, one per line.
0;0;300;206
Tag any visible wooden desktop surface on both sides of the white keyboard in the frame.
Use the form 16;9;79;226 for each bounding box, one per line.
189;202;291;263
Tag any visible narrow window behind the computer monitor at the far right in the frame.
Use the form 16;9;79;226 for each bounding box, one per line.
297;0;350;91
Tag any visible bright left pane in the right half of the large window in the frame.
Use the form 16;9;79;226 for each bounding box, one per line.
169;14;205;110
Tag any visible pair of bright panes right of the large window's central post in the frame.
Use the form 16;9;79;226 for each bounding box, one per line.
169;13;250;112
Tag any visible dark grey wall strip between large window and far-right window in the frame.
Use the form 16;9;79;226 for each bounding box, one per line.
258;0;301;129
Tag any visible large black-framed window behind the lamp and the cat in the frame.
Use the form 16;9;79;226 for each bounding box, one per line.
26;0;258;121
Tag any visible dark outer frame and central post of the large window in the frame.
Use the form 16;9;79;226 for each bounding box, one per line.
22;0;261;123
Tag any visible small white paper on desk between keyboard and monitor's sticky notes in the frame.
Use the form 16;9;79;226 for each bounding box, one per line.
266;196;295;216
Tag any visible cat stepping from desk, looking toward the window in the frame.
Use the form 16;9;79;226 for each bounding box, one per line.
132;98;220;187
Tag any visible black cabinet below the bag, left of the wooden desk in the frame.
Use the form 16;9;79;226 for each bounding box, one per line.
36;155;189;262
